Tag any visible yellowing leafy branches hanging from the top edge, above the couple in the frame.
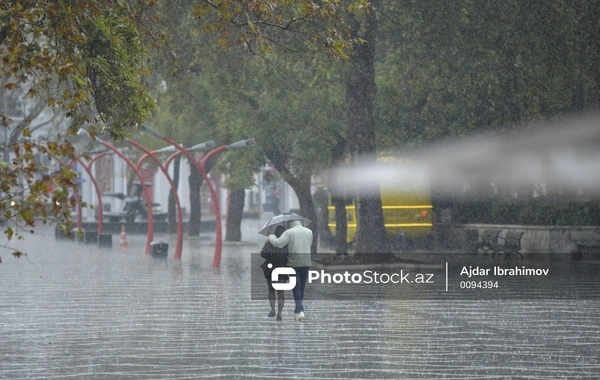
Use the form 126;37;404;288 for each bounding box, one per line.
192;0;360;59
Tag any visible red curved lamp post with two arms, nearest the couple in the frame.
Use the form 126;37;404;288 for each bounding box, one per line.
140;125;256;267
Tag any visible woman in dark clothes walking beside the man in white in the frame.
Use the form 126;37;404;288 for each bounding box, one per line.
260;226;288;321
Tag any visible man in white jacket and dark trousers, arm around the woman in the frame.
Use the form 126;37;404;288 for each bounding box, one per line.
269;220;312;321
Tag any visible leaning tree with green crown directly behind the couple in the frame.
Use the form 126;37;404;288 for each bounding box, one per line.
206;49;344;250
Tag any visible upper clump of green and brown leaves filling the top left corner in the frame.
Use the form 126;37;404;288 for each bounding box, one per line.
0;0;163;137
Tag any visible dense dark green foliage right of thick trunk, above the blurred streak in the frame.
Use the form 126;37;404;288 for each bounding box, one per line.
377;0;600;147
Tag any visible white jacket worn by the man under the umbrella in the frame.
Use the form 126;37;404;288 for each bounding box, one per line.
269;220;312;267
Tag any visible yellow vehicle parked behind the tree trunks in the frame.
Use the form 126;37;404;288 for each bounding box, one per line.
327;159;433;243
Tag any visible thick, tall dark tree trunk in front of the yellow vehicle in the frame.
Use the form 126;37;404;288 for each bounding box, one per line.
346;2;391;262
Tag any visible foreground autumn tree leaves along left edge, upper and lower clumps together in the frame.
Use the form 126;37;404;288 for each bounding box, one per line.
0;0;163;258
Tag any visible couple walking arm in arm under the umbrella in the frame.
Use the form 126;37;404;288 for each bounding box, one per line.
261;220;313;321
